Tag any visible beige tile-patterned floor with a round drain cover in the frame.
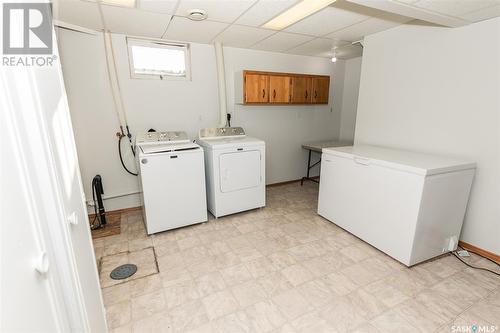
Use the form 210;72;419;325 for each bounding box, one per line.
94;183;500;333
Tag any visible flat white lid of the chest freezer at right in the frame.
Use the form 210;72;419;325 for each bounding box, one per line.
322;145;476;176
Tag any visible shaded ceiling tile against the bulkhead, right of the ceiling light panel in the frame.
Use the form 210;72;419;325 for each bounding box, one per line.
326;14;408;42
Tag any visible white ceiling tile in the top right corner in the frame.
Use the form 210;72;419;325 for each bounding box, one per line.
413;0;499;17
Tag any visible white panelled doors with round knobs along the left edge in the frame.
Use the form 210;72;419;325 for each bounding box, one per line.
0;25;106;332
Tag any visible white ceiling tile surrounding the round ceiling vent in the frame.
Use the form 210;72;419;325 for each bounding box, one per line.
176;0;256;23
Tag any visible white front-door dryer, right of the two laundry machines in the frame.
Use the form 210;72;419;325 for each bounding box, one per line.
198;127;266;217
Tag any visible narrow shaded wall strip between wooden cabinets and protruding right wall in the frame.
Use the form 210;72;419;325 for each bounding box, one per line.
339;57;362;141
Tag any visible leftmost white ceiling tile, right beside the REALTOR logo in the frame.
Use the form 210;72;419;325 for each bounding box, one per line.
52;0;103;30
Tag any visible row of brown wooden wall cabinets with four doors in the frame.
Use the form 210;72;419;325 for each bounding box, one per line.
235;70;330;105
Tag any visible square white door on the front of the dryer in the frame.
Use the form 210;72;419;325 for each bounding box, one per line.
219;150;262;193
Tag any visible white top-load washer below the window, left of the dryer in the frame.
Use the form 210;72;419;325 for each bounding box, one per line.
136;131;207;235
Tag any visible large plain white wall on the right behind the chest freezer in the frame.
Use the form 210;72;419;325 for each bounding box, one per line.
355;18;500;253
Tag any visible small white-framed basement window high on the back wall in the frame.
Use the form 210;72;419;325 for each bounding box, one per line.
127;38;190;80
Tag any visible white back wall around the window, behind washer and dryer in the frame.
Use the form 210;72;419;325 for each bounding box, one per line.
59;30;344;210
